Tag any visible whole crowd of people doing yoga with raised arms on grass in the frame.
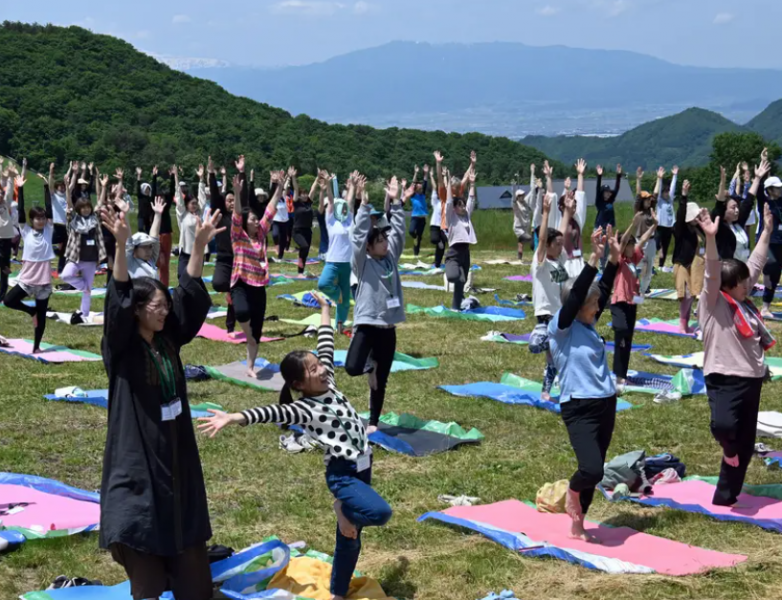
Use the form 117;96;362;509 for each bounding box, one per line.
0;146;782;600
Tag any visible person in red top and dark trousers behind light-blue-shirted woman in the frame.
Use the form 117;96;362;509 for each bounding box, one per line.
611;211;657;394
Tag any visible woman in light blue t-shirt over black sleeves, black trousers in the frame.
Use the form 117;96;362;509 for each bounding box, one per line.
549;225;620;542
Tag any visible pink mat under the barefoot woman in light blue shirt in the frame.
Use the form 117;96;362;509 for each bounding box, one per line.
443;496;747;575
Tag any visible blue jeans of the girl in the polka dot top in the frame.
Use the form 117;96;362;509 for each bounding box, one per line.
326;458;391;596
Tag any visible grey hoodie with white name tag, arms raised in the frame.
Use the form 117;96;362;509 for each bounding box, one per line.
351;204;405;327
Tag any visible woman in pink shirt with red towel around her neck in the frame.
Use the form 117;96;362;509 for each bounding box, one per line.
698;195;776;508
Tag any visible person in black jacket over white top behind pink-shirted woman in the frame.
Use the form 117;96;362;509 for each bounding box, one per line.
711;167;762;262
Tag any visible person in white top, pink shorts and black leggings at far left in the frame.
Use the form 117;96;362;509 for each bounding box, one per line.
4;172;55;354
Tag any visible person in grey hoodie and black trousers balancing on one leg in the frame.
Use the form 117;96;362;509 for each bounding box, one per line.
345;176;416;433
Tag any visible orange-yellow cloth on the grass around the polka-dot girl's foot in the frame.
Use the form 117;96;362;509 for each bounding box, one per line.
267;556;394;600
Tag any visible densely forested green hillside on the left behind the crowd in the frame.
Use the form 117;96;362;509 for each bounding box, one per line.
0;22;562;183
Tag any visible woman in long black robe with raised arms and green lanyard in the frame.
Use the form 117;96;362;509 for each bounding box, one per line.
100;204;225;600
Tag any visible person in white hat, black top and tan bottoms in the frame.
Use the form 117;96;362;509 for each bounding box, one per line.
673;180;706;334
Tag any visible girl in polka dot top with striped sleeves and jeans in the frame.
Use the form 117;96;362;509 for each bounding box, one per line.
198;295;391;600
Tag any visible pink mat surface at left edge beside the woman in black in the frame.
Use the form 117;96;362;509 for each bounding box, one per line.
0;484;100;533
